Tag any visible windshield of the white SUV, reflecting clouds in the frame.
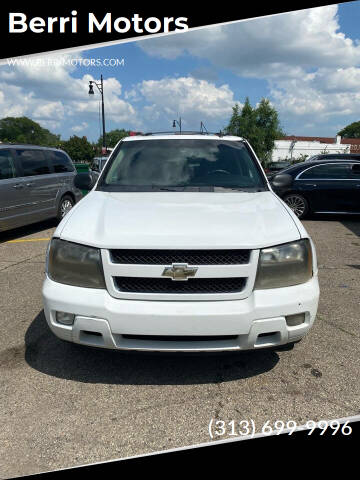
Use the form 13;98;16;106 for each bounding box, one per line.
98;139;266;191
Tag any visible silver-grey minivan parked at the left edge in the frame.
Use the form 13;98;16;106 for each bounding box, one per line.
0;143;82;232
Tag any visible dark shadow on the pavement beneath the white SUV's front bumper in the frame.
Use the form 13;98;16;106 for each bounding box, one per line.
25;311;279;385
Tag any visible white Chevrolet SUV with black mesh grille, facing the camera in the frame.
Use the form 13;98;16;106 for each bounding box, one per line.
43;134;319;352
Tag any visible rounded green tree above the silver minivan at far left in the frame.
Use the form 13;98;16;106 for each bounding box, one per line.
0;117;60;147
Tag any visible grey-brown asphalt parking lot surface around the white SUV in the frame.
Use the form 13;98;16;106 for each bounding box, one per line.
0;217;360;478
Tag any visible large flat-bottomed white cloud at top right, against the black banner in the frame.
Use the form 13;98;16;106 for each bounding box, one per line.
138;5;360;78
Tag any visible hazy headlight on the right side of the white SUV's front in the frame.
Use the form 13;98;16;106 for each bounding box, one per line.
255;239;313;290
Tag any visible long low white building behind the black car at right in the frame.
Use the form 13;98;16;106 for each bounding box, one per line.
272;135;360;162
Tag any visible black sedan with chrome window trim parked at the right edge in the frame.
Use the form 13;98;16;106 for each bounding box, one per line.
270;160;360;218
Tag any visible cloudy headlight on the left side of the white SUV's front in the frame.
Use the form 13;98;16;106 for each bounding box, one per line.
47;238;105;288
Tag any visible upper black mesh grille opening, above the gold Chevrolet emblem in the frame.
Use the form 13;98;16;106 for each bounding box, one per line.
110;250;250;265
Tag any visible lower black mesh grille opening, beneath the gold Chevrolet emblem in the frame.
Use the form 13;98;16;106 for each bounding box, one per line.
114;277;246;294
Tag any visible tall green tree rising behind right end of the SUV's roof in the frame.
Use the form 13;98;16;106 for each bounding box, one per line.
226;97;284;162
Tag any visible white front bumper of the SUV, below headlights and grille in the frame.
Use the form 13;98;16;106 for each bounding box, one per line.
43;276;319;352
